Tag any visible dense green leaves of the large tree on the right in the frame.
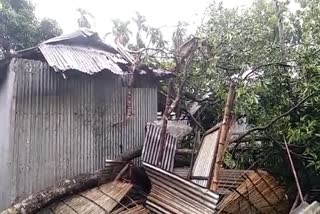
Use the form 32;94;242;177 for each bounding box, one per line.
195;0;320;191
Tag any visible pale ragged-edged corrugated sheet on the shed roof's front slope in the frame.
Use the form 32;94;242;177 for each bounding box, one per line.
39;44;127;75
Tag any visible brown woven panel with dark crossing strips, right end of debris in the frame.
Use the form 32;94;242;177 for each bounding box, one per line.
218;171;288;214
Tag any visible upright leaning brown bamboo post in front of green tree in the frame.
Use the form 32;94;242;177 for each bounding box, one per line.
210;83;235;191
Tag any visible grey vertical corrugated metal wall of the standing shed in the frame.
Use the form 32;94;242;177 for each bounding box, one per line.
0;59;157;209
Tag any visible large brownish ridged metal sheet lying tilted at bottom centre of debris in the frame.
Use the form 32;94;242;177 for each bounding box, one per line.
143;163;219;214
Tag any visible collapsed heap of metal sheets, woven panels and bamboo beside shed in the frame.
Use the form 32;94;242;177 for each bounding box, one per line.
1;86;302;214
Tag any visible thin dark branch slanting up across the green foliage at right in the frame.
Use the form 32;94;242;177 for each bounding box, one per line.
232;93;316;142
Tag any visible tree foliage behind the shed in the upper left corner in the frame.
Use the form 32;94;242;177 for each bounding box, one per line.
0;0;62;58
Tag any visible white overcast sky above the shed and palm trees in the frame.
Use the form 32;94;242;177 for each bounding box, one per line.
32;0;252;39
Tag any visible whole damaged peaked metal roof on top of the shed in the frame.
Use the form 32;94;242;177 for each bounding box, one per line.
0;28;175;79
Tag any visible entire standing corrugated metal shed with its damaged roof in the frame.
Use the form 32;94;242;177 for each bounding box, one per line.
0;29;172;210
